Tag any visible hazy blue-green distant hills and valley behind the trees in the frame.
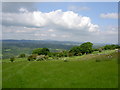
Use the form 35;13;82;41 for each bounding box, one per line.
2;40;105;58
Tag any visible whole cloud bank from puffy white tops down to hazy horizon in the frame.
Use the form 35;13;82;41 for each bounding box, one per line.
2;9;118;43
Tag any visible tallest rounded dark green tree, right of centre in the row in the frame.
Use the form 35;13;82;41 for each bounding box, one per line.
80;42;93;54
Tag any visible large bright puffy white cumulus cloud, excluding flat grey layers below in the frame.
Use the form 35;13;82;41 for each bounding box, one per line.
3;8;99;32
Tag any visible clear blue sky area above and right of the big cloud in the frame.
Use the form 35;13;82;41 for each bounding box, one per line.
35;2;118;26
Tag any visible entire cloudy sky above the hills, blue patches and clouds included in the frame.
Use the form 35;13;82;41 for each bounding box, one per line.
2;2;118;43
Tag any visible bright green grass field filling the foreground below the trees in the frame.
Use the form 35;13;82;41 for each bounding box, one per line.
2;51;118;88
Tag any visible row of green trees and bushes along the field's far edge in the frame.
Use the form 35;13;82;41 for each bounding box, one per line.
10;42;120;62
